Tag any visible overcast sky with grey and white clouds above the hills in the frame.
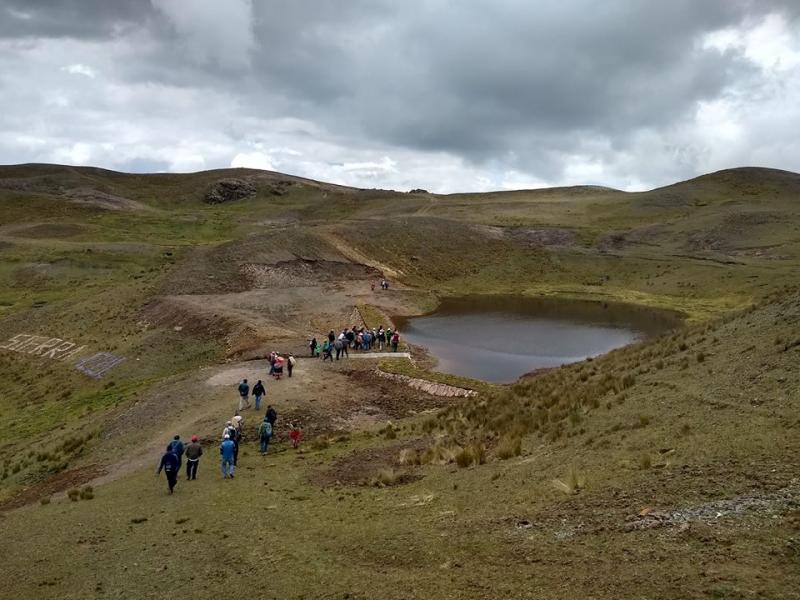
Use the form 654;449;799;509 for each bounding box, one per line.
0;0;800;192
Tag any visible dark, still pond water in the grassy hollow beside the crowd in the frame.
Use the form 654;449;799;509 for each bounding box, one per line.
396;296;680;383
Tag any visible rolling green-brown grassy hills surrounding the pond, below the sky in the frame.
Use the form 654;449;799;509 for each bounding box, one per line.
0;165;800;598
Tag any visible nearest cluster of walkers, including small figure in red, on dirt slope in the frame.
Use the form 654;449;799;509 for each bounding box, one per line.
156;404;302;494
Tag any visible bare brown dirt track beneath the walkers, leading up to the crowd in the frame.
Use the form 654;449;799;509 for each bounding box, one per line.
0;358;452;511
